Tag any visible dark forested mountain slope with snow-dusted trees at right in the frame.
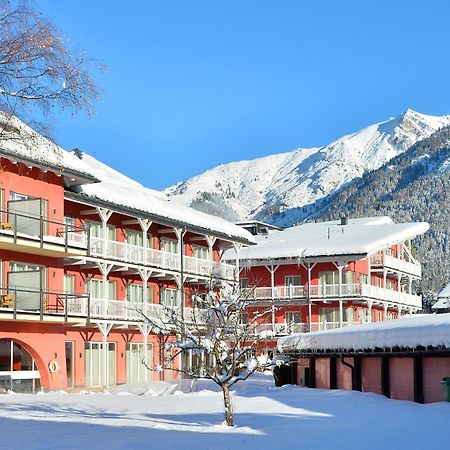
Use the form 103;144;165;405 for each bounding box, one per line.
311;126;450;303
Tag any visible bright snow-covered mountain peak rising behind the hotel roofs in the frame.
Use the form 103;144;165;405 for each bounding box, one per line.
165;109;450;226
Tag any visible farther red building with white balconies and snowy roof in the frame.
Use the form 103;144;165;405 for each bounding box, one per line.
230;217;428;354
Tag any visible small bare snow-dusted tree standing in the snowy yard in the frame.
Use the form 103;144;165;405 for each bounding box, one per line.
140;282;272;426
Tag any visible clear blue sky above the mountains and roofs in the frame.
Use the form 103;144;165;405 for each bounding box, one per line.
37;0;450;189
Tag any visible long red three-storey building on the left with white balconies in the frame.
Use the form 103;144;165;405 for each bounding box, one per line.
0;124;253;392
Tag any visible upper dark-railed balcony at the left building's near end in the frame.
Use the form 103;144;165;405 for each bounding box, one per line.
0;209;88;256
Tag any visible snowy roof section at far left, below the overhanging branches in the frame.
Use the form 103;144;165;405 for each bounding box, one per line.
0;112;95;184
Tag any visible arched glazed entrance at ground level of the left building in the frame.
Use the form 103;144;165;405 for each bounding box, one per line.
0;339;41;392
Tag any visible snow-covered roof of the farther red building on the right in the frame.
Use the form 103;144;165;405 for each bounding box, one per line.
225;216;429;261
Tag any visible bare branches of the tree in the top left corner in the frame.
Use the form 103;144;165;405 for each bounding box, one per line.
0;0;101;139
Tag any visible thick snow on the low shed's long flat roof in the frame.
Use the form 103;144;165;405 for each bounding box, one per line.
278;314;450;352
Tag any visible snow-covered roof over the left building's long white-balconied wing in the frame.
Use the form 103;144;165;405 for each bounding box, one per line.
69;151;255;244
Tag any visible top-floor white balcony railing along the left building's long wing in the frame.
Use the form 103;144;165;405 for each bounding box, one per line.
89;236;235;280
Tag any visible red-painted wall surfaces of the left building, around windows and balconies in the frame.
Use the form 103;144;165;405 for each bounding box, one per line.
0;159;232;389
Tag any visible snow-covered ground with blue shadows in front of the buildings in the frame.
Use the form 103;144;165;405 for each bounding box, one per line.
0;375;450;450
